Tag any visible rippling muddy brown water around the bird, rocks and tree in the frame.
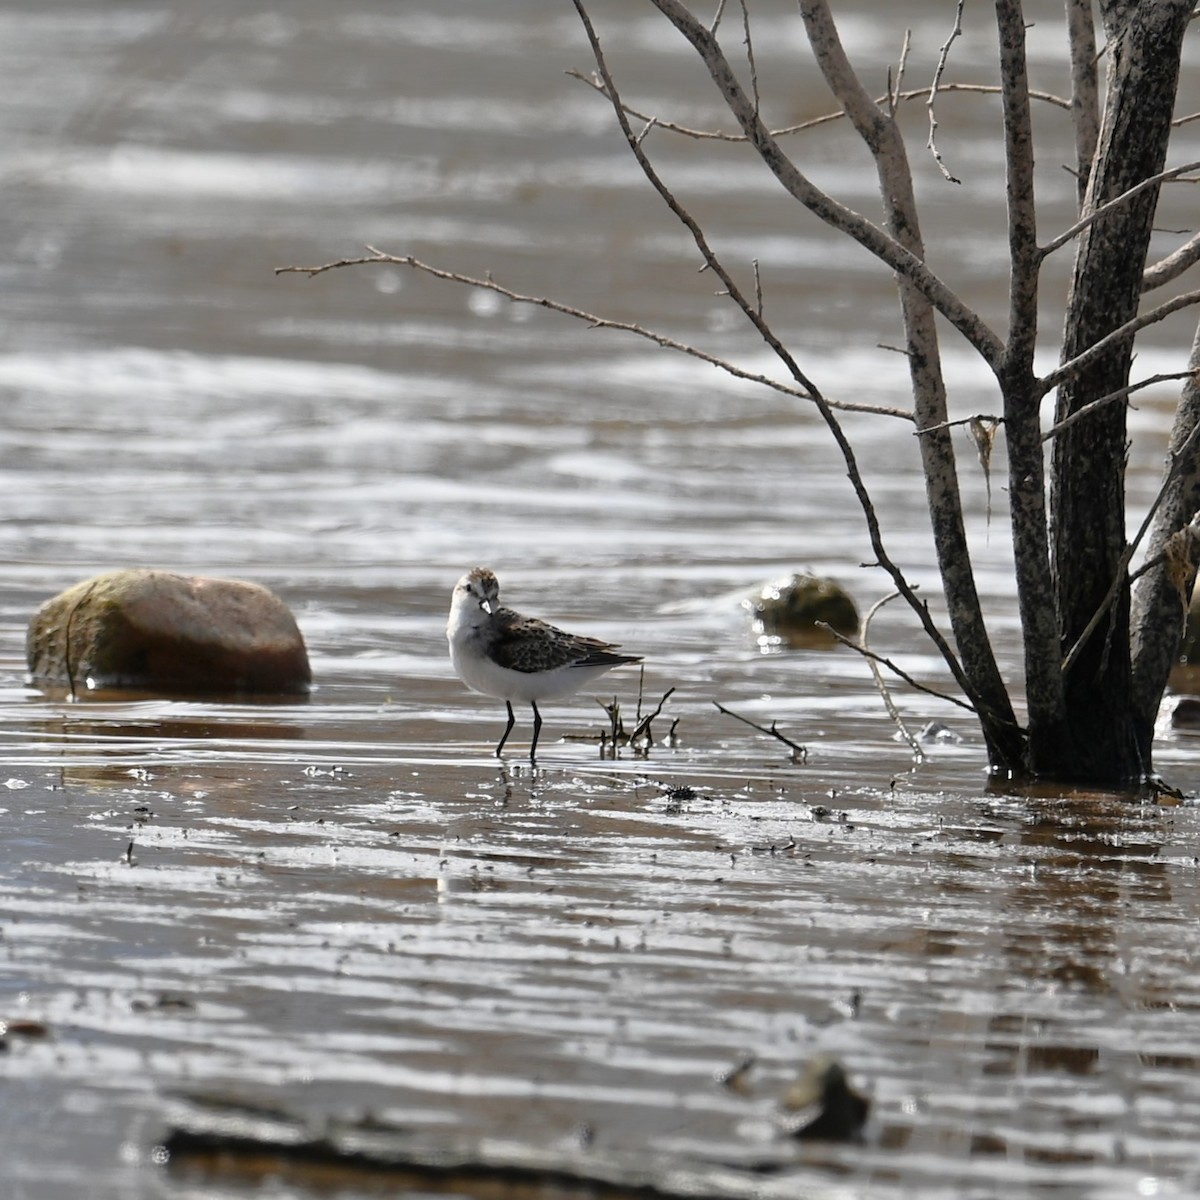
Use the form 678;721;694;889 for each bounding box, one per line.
0;0;1200;1200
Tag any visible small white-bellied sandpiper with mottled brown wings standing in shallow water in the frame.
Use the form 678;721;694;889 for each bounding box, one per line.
446;566;642;762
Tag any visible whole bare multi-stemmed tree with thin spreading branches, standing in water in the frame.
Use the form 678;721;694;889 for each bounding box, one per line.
280;0;1200;785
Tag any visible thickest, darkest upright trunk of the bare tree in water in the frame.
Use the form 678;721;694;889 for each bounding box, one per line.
1046;0;1192;782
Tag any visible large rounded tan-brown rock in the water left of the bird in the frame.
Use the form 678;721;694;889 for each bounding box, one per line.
25;569;312;696
